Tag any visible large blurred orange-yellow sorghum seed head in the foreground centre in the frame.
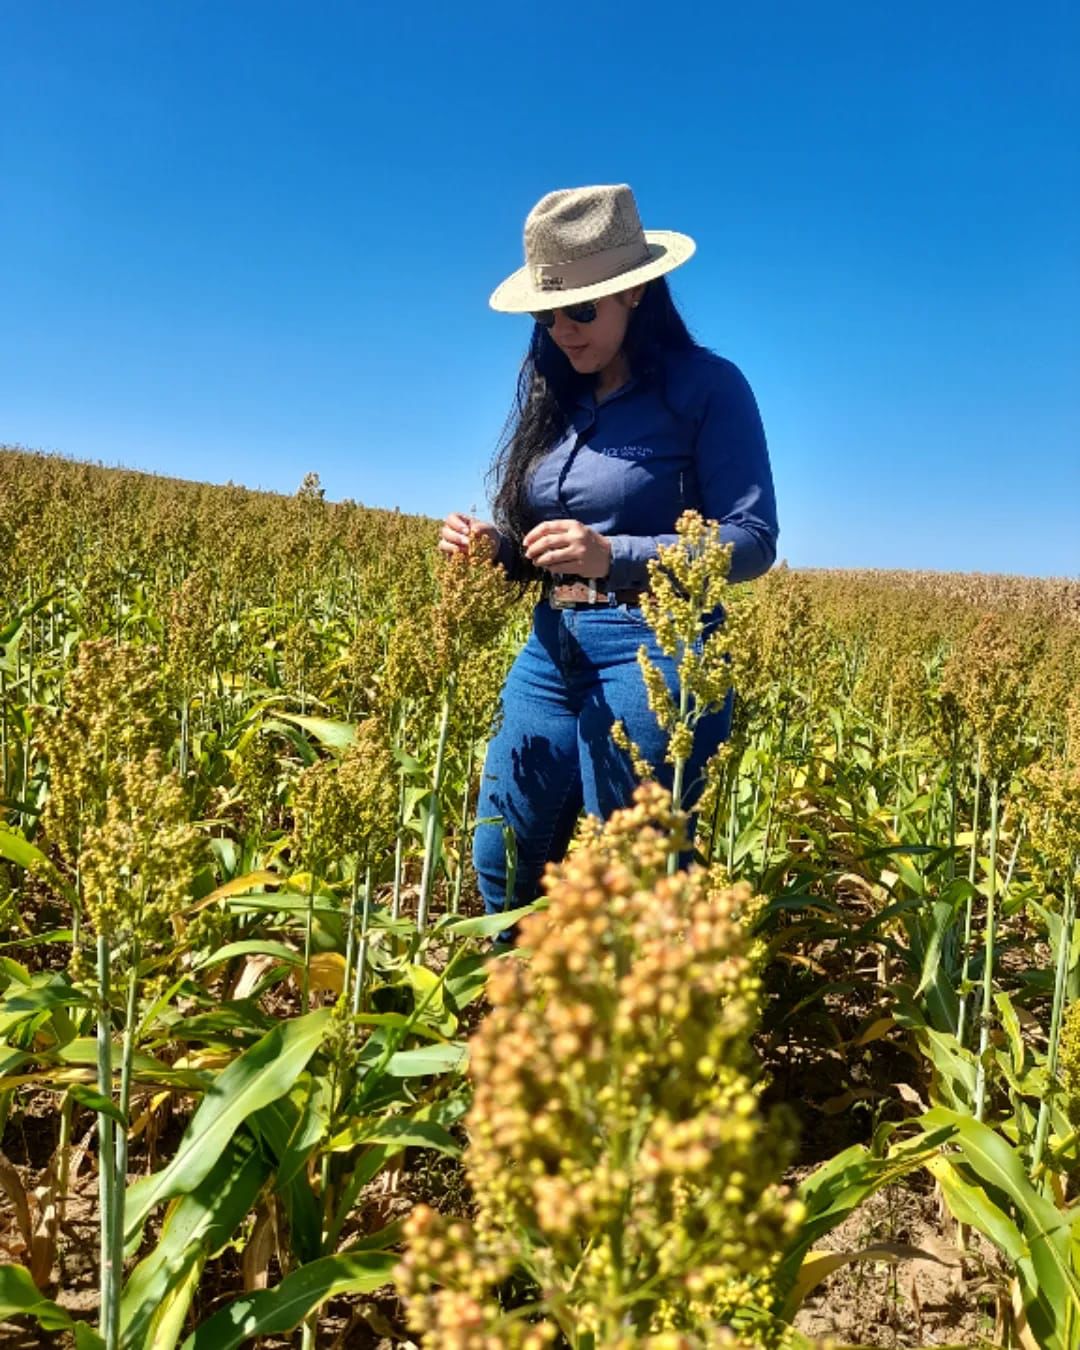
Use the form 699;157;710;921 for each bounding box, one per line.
398;784;799;1350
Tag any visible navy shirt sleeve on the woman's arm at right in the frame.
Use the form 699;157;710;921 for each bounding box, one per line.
608;360;779;590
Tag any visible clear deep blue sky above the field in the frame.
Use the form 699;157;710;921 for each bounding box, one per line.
0;0;1080;575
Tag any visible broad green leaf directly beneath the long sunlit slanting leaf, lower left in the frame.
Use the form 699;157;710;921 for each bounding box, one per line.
120;1130;266;1350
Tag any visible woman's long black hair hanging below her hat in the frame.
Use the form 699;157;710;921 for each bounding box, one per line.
487;277;697;569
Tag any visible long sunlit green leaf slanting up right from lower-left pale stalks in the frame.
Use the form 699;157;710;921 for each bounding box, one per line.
124;1008;332;1242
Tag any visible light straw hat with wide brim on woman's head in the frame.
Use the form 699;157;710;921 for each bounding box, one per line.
490;182;697;315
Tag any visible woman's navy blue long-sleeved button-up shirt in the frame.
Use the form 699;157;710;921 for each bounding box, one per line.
497;347;778;590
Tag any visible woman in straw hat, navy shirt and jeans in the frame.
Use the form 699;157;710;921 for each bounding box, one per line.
439;185;776;913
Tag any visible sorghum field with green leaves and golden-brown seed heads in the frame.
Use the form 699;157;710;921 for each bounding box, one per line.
0;451;1080;1350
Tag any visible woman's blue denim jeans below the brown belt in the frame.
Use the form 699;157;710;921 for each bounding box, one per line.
473;601;732;914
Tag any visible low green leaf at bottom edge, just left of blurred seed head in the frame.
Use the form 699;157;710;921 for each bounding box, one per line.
184;1251;398;1350
